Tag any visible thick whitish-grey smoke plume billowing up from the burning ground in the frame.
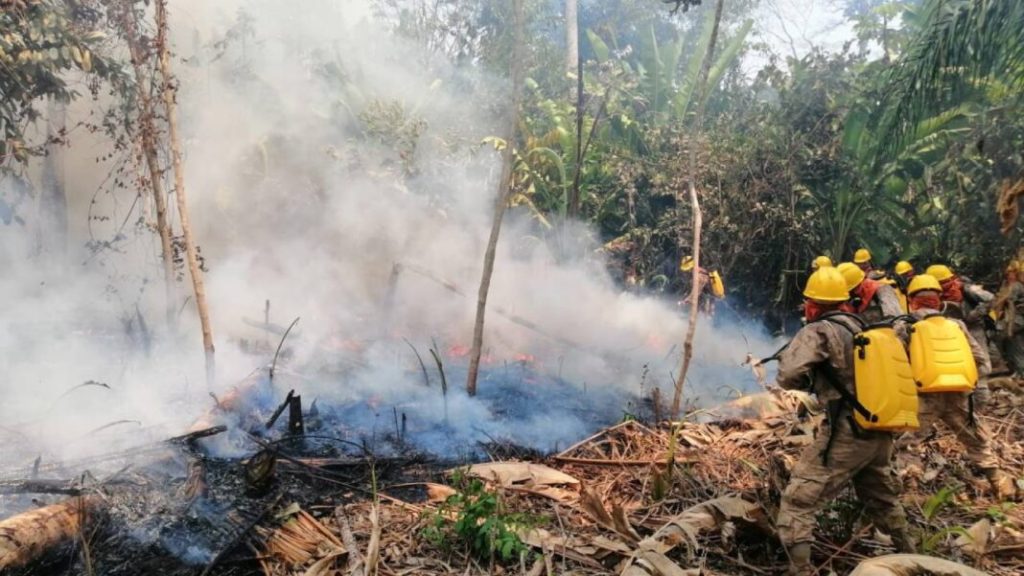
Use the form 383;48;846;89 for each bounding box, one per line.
0;0;772;483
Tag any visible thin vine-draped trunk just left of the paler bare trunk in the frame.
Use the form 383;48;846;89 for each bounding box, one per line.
122;3;177;330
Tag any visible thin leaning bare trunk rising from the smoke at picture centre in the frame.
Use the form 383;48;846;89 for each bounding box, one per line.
466;0;524;396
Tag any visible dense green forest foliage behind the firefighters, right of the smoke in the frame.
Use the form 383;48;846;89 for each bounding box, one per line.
366;0;1024;324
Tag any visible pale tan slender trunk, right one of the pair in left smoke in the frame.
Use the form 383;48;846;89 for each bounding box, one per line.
157;0;216;385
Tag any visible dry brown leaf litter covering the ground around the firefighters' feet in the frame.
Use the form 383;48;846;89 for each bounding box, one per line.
255;381;1024;576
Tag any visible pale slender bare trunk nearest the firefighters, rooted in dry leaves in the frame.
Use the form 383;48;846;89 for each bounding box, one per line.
672;0;725;420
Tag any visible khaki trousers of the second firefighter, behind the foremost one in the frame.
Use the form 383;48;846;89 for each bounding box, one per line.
900;393;999;470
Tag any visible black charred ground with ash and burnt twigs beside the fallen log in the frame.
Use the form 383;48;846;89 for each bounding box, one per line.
12;444;453;576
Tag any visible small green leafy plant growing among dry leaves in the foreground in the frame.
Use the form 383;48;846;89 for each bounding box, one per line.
422;474;541;564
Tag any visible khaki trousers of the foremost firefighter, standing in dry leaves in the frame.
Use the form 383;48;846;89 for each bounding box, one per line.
776;414;906;548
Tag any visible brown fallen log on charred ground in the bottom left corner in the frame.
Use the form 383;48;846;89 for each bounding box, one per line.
0;496;99;573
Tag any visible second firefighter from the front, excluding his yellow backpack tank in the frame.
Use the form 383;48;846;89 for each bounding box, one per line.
907;274;1017;500
